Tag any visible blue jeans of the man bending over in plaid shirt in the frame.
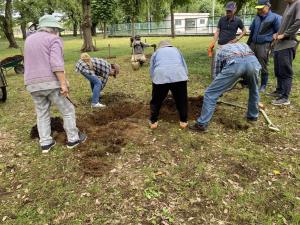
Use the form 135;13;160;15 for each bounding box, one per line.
197;56;261;126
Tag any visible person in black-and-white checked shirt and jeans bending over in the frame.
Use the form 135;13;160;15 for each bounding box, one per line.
76;53;120;108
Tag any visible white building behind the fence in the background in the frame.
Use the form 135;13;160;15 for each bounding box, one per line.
166;13;209;34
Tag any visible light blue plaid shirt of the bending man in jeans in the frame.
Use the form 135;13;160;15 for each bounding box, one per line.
213;43;254;78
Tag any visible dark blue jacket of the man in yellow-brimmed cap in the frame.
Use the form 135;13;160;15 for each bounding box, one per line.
249;10;281;44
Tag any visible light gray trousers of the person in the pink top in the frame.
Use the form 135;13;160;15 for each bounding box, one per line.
31;89;79;146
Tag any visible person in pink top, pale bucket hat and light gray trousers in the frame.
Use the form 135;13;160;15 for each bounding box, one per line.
24;15;87;153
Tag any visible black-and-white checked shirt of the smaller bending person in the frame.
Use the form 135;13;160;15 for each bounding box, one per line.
76;58;111;88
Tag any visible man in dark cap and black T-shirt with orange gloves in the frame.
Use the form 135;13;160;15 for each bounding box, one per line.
209;2;247;49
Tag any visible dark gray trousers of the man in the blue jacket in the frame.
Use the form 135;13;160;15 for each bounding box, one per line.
250;42;271;85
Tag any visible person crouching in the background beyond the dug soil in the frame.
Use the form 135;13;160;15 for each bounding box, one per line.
130;35;156;70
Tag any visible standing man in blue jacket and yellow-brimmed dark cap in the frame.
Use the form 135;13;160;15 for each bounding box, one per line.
247;0;281;92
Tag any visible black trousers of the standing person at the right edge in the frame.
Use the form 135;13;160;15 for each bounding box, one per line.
274;48;296;98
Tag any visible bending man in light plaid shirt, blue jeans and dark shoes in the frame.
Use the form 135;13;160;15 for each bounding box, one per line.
190;43;261;132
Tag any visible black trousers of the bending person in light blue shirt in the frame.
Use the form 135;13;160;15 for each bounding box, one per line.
150;81;188;123
